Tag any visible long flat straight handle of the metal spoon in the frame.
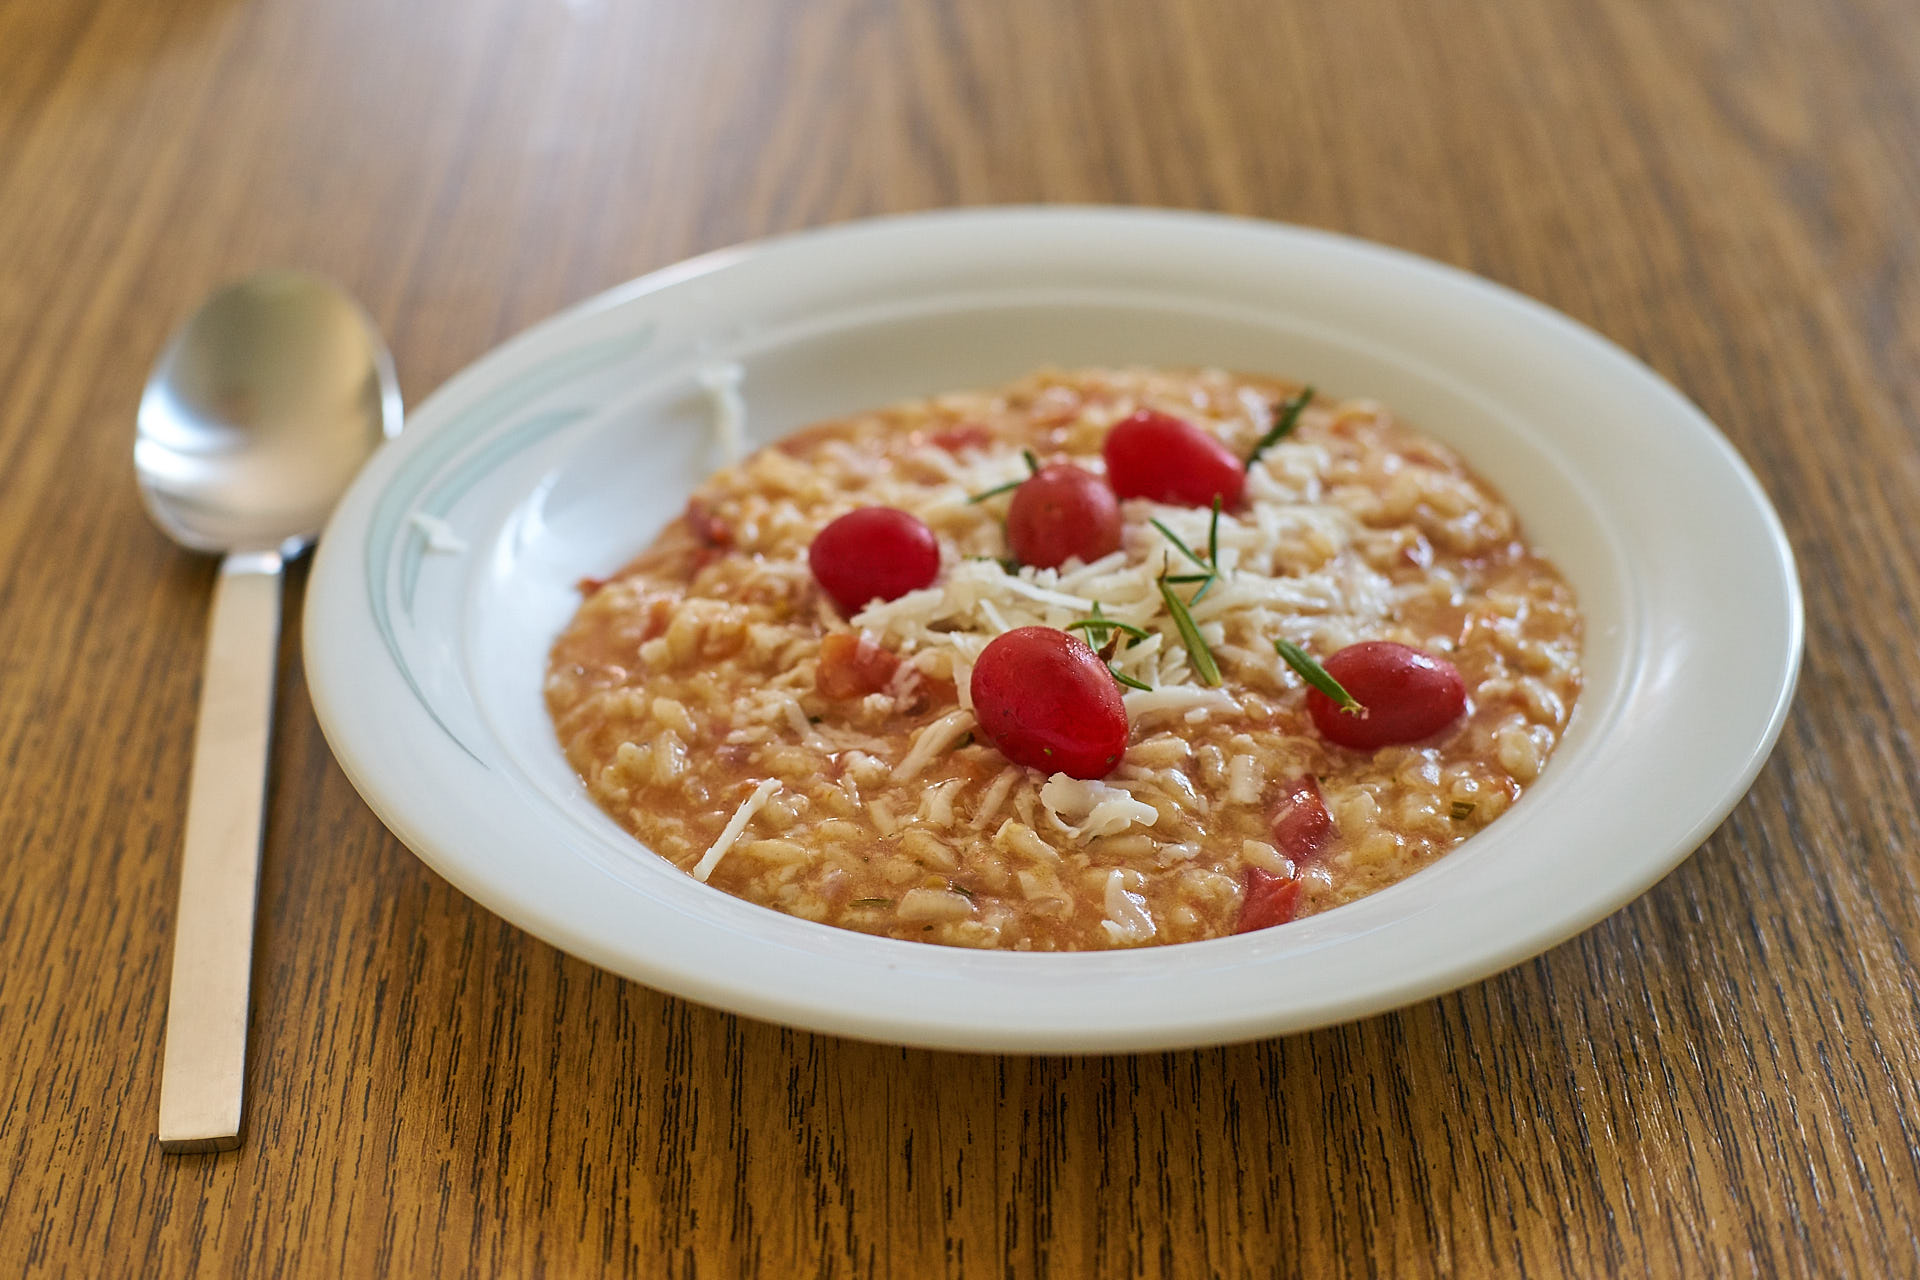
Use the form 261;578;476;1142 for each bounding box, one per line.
159;551;280;1151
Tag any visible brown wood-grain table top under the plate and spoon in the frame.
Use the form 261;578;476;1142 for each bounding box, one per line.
0;0;1920;1276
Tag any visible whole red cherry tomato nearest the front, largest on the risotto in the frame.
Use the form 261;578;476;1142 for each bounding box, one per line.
970;628;1127;777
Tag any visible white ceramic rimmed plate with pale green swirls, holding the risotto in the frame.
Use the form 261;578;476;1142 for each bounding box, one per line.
305;209;1801;1052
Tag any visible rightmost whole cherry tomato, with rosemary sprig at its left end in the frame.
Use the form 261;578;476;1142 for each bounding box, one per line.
1308;641;1467;750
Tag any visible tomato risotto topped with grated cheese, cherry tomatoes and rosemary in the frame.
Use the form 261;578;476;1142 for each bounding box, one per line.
545;368;1580;950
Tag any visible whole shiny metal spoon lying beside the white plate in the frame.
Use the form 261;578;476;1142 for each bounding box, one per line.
132;271;401;1151
